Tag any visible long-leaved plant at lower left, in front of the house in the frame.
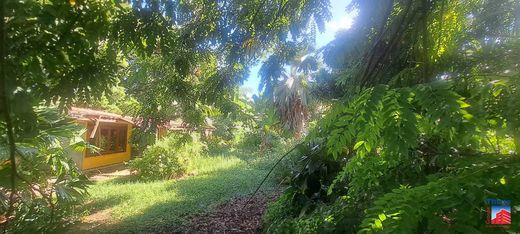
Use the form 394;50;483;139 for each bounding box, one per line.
0;107;89;233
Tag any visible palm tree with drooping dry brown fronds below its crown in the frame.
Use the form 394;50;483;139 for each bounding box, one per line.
258;41;319;138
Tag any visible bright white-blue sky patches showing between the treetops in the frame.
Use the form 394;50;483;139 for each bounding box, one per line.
241;0;353;96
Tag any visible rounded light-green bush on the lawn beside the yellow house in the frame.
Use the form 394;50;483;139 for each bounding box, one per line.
129;133;206;179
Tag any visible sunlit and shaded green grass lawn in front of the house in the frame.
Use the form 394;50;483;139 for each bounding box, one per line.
78;154;279;233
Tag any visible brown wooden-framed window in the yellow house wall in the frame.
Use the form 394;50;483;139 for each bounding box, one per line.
88;123;127;156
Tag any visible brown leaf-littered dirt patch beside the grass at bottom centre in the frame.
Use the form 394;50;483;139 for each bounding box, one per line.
165;193;278;233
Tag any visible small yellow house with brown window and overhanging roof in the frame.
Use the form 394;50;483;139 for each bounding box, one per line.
68;107;134;170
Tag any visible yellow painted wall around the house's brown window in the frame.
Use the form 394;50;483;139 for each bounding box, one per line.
81;121;132;170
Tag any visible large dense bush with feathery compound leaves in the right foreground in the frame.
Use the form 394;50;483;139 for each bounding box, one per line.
266;82;520;233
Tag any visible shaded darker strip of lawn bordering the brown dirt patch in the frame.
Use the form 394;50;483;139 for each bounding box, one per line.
96;161;274;233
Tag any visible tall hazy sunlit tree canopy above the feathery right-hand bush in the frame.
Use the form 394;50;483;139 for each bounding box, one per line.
323;1;520;87
